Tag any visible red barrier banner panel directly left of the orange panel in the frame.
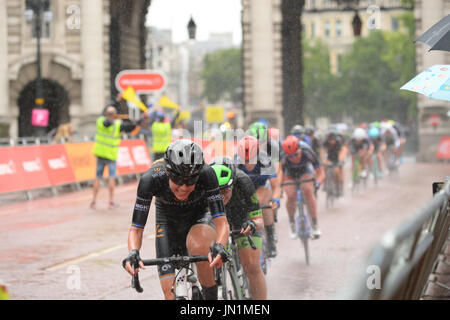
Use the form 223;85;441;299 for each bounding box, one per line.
40;144;76;186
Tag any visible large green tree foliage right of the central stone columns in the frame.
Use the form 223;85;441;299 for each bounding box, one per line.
303;23;417;122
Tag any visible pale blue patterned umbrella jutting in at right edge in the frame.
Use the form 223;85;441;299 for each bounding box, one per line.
400;65;450;101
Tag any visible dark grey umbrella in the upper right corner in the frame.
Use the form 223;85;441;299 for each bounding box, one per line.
416;14;450;51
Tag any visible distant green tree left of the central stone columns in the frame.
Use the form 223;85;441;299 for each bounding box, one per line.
202;48;242;103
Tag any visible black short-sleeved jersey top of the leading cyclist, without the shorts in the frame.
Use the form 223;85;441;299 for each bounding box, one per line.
132;161;225;229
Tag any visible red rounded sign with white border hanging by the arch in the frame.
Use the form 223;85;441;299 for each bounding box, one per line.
116;70;166;93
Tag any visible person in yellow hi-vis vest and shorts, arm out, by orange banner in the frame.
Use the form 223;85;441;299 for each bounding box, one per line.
90;105;136;209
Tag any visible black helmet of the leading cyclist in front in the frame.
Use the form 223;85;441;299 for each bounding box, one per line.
164;139;205;177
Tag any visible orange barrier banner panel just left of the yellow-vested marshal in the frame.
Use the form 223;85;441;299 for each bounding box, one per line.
64;142;97;182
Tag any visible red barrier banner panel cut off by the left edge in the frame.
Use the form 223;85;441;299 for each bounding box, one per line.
0;147;24;193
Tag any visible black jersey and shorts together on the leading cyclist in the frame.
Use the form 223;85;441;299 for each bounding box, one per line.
132;160;225;278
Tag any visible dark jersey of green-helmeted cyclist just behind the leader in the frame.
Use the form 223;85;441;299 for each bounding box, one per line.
225;169;262;229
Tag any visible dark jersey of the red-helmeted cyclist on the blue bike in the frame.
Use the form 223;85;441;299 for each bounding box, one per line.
281;141;320;178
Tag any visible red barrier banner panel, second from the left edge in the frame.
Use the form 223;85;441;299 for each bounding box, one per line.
12;145;51;190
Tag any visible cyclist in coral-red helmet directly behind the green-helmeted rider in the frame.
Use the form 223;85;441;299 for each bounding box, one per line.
234;136;281;258
